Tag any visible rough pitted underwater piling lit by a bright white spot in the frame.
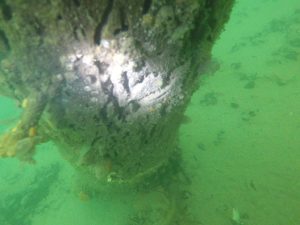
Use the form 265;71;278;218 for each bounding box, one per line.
0;0;233;186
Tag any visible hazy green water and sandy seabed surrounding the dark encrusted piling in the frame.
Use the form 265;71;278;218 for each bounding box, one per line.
0;0;300;225
